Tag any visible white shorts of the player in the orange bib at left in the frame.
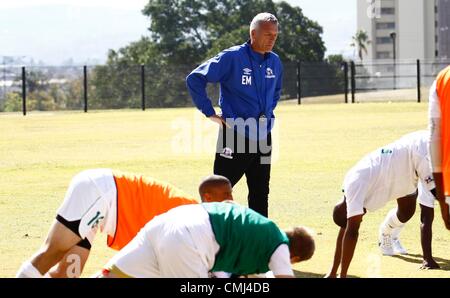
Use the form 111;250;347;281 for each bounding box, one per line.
57;169;117;244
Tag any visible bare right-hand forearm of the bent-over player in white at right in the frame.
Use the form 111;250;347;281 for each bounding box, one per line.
340;214;363;278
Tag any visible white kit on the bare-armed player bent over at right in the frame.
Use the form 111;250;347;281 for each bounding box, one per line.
343;131;435;218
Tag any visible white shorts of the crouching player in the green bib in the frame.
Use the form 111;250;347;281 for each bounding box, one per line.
106;204;219;278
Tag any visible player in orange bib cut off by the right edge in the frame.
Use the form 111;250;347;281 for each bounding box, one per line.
429;66;450;230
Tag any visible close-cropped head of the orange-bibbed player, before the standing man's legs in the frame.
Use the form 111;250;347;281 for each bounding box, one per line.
198;175;233;202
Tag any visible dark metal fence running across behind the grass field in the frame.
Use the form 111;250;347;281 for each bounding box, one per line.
0;60;450;114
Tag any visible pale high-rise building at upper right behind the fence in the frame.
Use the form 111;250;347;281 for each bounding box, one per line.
356;0;450;61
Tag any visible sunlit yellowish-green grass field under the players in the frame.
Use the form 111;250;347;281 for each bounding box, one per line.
0;103;450;278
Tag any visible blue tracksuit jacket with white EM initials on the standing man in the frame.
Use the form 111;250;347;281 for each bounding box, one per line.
186;42;283;139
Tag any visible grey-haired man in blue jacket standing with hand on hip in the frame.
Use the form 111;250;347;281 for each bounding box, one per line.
186;13;283;217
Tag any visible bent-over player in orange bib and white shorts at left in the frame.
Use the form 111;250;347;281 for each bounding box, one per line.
16;169;233;277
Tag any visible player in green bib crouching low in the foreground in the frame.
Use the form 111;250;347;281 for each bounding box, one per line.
102;203;315;278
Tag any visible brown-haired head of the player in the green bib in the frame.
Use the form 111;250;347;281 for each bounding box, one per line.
285;227;316;263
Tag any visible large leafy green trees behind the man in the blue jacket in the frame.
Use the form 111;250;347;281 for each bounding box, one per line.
89;0;325;108
